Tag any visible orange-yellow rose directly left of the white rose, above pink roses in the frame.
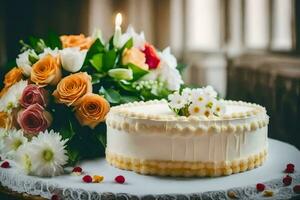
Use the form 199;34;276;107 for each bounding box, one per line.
30;54;61;86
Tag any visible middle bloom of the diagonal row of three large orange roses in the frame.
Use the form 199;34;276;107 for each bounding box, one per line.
53;72;93;106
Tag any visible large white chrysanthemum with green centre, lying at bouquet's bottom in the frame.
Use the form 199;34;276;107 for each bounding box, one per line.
28;130;68;176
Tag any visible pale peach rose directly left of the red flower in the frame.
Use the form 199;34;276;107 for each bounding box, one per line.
122;47;149;70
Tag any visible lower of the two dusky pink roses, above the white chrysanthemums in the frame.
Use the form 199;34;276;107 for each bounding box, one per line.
17;103;52;135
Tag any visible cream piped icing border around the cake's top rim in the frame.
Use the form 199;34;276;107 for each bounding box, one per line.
106;100;269;135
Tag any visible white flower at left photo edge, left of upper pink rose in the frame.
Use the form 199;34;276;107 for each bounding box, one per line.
0;80;27;113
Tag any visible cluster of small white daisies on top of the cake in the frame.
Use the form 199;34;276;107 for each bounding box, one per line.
168;86;226;118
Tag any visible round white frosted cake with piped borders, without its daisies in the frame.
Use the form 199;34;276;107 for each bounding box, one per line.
106;100;269;176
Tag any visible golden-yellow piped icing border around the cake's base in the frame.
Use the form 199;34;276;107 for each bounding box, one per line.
106;149;267;177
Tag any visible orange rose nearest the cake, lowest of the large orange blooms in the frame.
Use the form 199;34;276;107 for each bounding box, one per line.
75;93;110;129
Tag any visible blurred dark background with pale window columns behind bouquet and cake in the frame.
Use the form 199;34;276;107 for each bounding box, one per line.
0;0;300;148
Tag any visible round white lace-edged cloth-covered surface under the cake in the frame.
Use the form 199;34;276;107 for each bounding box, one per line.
0;139;300;200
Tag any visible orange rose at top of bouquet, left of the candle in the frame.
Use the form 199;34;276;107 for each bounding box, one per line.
60;34;93;50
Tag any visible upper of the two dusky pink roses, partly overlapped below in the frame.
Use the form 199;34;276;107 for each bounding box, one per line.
20;84;48;108
